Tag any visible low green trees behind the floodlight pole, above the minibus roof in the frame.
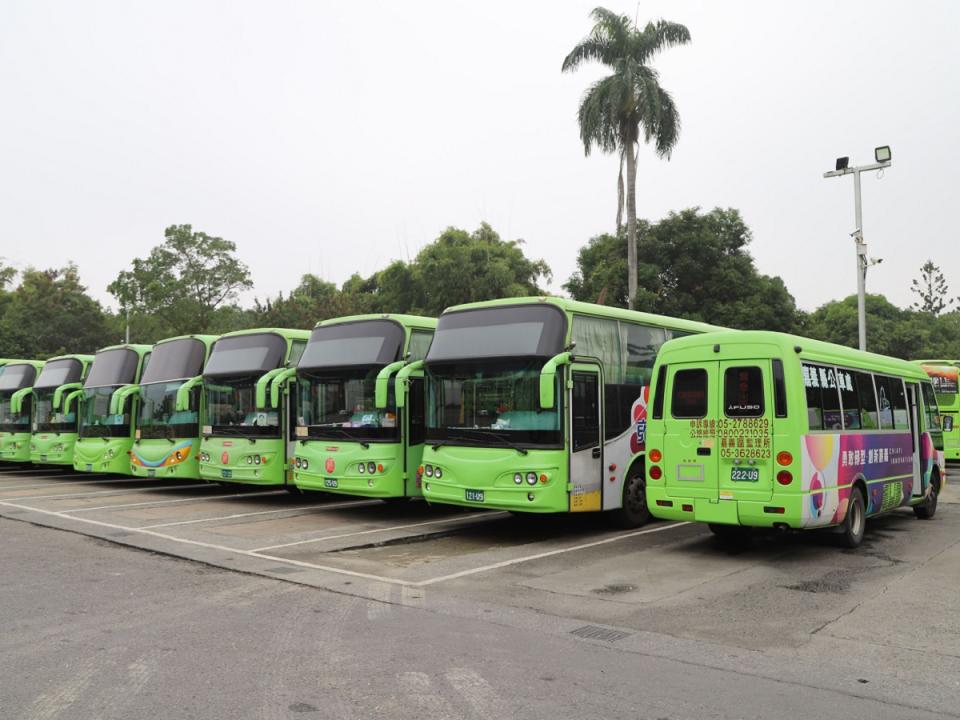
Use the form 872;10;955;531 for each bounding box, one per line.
804;295;960;360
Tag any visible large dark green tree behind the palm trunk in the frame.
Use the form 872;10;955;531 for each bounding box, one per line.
564;208;801;332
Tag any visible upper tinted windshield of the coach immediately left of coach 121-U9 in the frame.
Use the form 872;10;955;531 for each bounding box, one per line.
299;320;403;369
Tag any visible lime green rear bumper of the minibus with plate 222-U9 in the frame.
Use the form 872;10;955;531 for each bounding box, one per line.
647;487;803;529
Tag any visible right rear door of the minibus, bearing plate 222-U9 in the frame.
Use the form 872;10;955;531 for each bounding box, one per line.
715;359;776;501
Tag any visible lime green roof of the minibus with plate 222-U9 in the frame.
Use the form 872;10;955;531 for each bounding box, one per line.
657;330;927;380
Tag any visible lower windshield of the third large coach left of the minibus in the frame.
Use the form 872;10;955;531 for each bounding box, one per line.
205;376;280;438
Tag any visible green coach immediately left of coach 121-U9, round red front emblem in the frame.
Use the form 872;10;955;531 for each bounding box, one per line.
293;315;437;500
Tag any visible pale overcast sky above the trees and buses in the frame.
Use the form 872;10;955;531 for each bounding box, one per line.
0;0;960;309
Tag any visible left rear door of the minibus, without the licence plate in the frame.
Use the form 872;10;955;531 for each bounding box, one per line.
663;362;720;502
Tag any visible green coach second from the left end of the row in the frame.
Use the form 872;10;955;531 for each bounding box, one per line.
30;355;93;467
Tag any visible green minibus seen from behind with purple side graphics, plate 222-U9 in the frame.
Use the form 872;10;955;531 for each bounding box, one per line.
647;331;944;547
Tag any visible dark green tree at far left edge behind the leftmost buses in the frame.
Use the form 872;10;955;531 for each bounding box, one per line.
0;265;111;360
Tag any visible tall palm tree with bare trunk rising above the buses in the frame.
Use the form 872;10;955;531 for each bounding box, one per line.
562;7;690;308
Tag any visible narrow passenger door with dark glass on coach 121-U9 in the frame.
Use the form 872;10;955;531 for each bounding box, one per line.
567;363;603;512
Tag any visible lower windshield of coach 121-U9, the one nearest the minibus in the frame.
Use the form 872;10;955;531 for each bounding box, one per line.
426;359;563;447
